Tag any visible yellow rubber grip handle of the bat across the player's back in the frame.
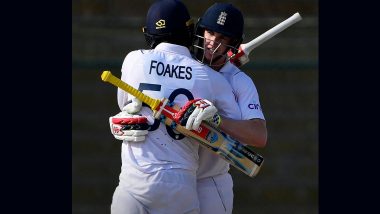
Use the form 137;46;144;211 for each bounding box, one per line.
101;71;160;110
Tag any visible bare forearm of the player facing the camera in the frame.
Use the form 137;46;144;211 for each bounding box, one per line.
219;118;267;148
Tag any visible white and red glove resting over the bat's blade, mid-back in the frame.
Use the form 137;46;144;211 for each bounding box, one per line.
175;99;221;130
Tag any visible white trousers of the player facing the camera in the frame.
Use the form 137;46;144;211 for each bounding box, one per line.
197;173;234;214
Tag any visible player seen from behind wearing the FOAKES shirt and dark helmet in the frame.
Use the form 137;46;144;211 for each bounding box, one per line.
110;0;240;214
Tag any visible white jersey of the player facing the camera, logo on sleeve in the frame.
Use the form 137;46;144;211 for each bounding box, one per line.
197;62;265;179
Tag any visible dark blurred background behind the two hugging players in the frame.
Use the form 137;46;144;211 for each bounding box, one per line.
72;0;318;214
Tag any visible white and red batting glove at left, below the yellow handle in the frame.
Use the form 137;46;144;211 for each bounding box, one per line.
109;99;149;142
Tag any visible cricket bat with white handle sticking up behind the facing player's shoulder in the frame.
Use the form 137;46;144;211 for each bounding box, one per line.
227;13;302;67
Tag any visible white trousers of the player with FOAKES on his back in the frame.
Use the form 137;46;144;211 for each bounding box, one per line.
111;168;200;214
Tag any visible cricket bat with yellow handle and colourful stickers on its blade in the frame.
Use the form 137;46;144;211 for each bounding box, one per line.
101;71;264;177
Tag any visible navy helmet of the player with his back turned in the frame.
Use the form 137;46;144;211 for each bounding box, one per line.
143;0;194;48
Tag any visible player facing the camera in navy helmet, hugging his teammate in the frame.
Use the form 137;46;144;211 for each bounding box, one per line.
193;3;267;214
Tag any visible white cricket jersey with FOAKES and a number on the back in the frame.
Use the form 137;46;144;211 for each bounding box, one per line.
118;43;240;177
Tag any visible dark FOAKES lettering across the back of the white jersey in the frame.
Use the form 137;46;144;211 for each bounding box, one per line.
149;60;192;80
